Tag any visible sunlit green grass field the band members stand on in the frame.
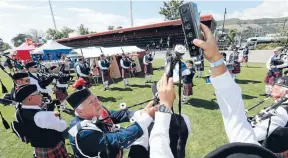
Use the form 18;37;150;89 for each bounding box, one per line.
0;60;267;158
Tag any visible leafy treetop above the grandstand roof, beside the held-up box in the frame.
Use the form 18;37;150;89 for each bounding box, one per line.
159;0;183;20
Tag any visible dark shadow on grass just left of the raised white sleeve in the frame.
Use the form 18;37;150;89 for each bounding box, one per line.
188;98;219;110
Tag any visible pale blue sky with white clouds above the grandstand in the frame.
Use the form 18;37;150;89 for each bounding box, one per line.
0;0;288;44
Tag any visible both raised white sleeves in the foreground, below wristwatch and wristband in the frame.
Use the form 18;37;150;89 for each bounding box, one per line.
149;71;260;158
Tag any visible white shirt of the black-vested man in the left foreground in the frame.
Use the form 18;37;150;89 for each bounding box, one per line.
21;105;67;132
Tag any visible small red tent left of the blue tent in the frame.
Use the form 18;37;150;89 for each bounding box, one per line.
16;42;36;60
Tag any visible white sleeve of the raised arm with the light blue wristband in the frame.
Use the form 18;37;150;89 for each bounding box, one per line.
210;71;260;145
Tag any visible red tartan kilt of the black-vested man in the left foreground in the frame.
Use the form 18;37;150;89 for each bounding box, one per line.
35;142;69;158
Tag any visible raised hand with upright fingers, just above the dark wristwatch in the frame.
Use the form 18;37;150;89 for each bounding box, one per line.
157;73;176;109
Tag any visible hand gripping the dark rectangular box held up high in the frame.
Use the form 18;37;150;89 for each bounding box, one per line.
193;24;222;62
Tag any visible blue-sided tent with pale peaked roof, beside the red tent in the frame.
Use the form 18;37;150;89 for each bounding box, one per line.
33;40;72;60
